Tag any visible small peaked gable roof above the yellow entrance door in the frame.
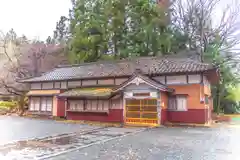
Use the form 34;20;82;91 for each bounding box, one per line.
113;69;174;92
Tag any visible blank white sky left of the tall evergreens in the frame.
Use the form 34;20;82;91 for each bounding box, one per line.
0;0;71;40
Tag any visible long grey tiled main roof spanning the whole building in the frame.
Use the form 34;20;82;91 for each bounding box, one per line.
22;57;216;82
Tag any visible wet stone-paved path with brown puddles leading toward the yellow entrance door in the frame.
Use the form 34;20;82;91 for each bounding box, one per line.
0;128;142;160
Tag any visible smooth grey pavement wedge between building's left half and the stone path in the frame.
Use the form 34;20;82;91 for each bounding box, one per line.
0;116;98;145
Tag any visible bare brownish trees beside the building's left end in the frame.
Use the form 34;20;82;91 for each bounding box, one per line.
0;31;66;114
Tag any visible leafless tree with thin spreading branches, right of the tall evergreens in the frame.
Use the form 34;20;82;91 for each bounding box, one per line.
172;0;240;60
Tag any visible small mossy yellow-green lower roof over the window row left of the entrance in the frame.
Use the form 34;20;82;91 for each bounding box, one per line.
58;88;112;97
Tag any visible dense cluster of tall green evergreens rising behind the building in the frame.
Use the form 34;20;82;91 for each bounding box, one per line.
70;0;175;63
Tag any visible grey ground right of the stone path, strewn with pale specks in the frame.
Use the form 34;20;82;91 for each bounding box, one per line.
51;127;240;160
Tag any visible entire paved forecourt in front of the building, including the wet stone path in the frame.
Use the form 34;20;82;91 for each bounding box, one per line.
0;117;240;160
